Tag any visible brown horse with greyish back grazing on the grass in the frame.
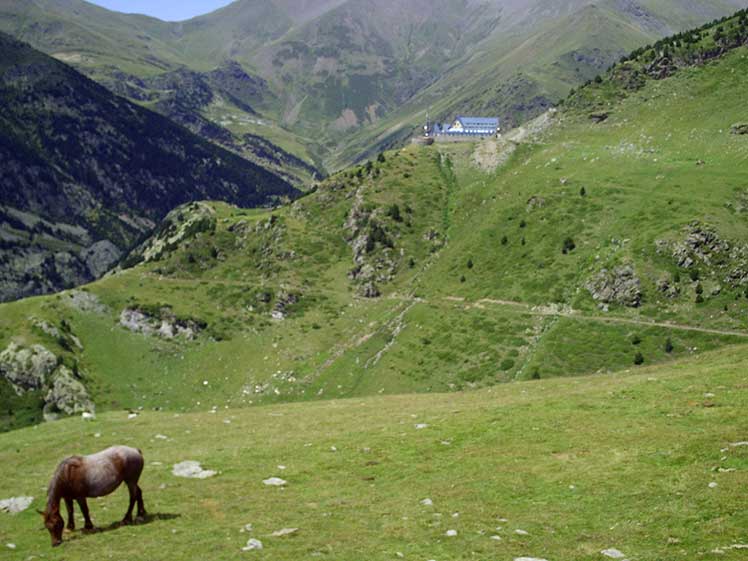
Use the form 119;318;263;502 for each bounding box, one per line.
40;446;145;547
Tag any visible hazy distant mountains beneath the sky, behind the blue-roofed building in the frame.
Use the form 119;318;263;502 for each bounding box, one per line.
0;0;748;171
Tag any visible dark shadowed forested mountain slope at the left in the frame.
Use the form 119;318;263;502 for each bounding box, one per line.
0;35;295;300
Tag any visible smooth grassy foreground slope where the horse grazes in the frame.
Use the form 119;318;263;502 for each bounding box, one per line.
0;347;748;561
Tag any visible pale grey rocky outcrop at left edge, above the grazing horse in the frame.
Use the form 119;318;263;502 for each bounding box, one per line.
0;343;95;421
